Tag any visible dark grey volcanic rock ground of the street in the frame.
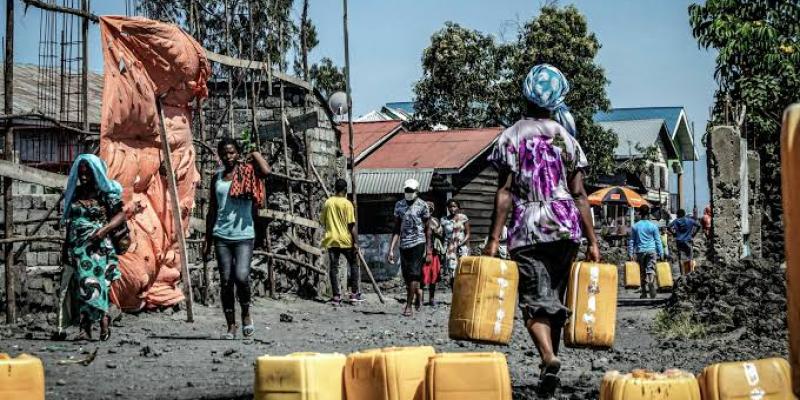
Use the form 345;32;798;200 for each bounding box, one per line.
0;278;788;399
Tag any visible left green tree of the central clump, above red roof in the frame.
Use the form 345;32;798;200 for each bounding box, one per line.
414;22;502;128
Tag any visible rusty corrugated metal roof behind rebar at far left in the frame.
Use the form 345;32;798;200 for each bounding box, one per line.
0;64;103;124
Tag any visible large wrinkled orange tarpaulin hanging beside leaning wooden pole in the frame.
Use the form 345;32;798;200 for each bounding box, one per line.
100;16;210;311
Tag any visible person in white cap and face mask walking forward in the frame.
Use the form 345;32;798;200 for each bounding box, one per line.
388;179;433;317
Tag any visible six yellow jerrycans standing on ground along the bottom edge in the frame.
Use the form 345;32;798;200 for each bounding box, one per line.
0;347;797;400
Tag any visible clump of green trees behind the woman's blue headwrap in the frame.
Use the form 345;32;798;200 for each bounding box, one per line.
414;5;617;176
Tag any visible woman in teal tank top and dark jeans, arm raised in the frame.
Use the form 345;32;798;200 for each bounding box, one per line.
203;138;270;339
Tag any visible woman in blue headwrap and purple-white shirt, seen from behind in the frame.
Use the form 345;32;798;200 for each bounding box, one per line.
484;64;600;393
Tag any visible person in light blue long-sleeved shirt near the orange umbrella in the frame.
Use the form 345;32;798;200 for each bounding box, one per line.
628;205;664;299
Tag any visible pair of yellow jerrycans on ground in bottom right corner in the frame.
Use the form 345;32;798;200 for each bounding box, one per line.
600;358;797;400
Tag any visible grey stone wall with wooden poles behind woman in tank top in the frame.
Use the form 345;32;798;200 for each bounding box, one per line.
200;82;346;297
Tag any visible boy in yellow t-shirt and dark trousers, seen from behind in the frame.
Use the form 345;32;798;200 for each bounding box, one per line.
322;179;364;303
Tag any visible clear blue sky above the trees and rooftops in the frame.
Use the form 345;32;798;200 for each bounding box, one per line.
3;0;716;209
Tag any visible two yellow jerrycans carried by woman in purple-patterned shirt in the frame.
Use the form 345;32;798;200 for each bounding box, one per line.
448;257;617;348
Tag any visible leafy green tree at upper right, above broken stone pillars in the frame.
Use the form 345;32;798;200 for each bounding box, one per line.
689;0;800;254
